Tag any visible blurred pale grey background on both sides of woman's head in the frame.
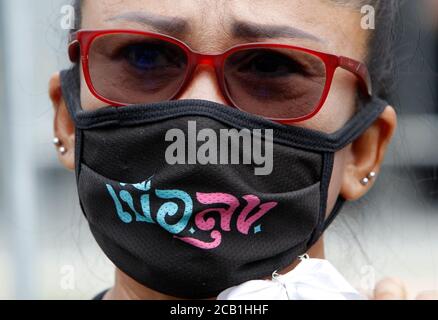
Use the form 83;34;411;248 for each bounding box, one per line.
0;0;438;299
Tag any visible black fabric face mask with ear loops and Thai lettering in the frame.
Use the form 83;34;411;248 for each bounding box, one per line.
61;66;386;299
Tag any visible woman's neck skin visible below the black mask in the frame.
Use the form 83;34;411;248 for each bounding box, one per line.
104;238;325;300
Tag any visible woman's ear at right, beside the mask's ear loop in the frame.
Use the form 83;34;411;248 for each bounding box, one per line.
340;106;397;201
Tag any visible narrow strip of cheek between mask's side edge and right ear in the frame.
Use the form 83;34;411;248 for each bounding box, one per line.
326;145;351;217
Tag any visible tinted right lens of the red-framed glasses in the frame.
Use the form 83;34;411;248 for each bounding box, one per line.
224;48;326;119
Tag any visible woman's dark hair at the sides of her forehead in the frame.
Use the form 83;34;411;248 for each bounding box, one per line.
73;0;400;100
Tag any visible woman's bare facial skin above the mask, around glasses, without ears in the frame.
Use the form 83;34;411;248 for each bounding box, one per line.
81;0;368;132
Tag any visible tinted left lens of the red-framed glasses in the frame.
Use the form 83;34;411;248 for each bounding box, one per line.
88;33;188;104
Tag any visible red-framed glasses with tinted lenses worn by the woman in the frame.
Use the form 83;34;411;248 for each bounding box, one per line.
69;30;371;122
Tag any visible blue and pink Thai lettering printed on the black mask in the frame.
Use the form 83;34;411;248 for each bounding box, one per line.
106;178;278;249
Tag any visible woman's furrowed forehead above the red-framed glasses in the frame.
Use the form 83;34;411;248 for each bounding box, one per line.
82;0;369;60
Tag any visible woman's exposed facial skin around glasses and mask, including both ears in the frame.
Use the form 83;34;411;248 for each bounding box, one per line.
51;0;396;239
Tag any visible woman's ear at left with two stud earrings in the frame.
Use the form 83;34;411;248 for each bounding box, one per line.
49;73;75;170
